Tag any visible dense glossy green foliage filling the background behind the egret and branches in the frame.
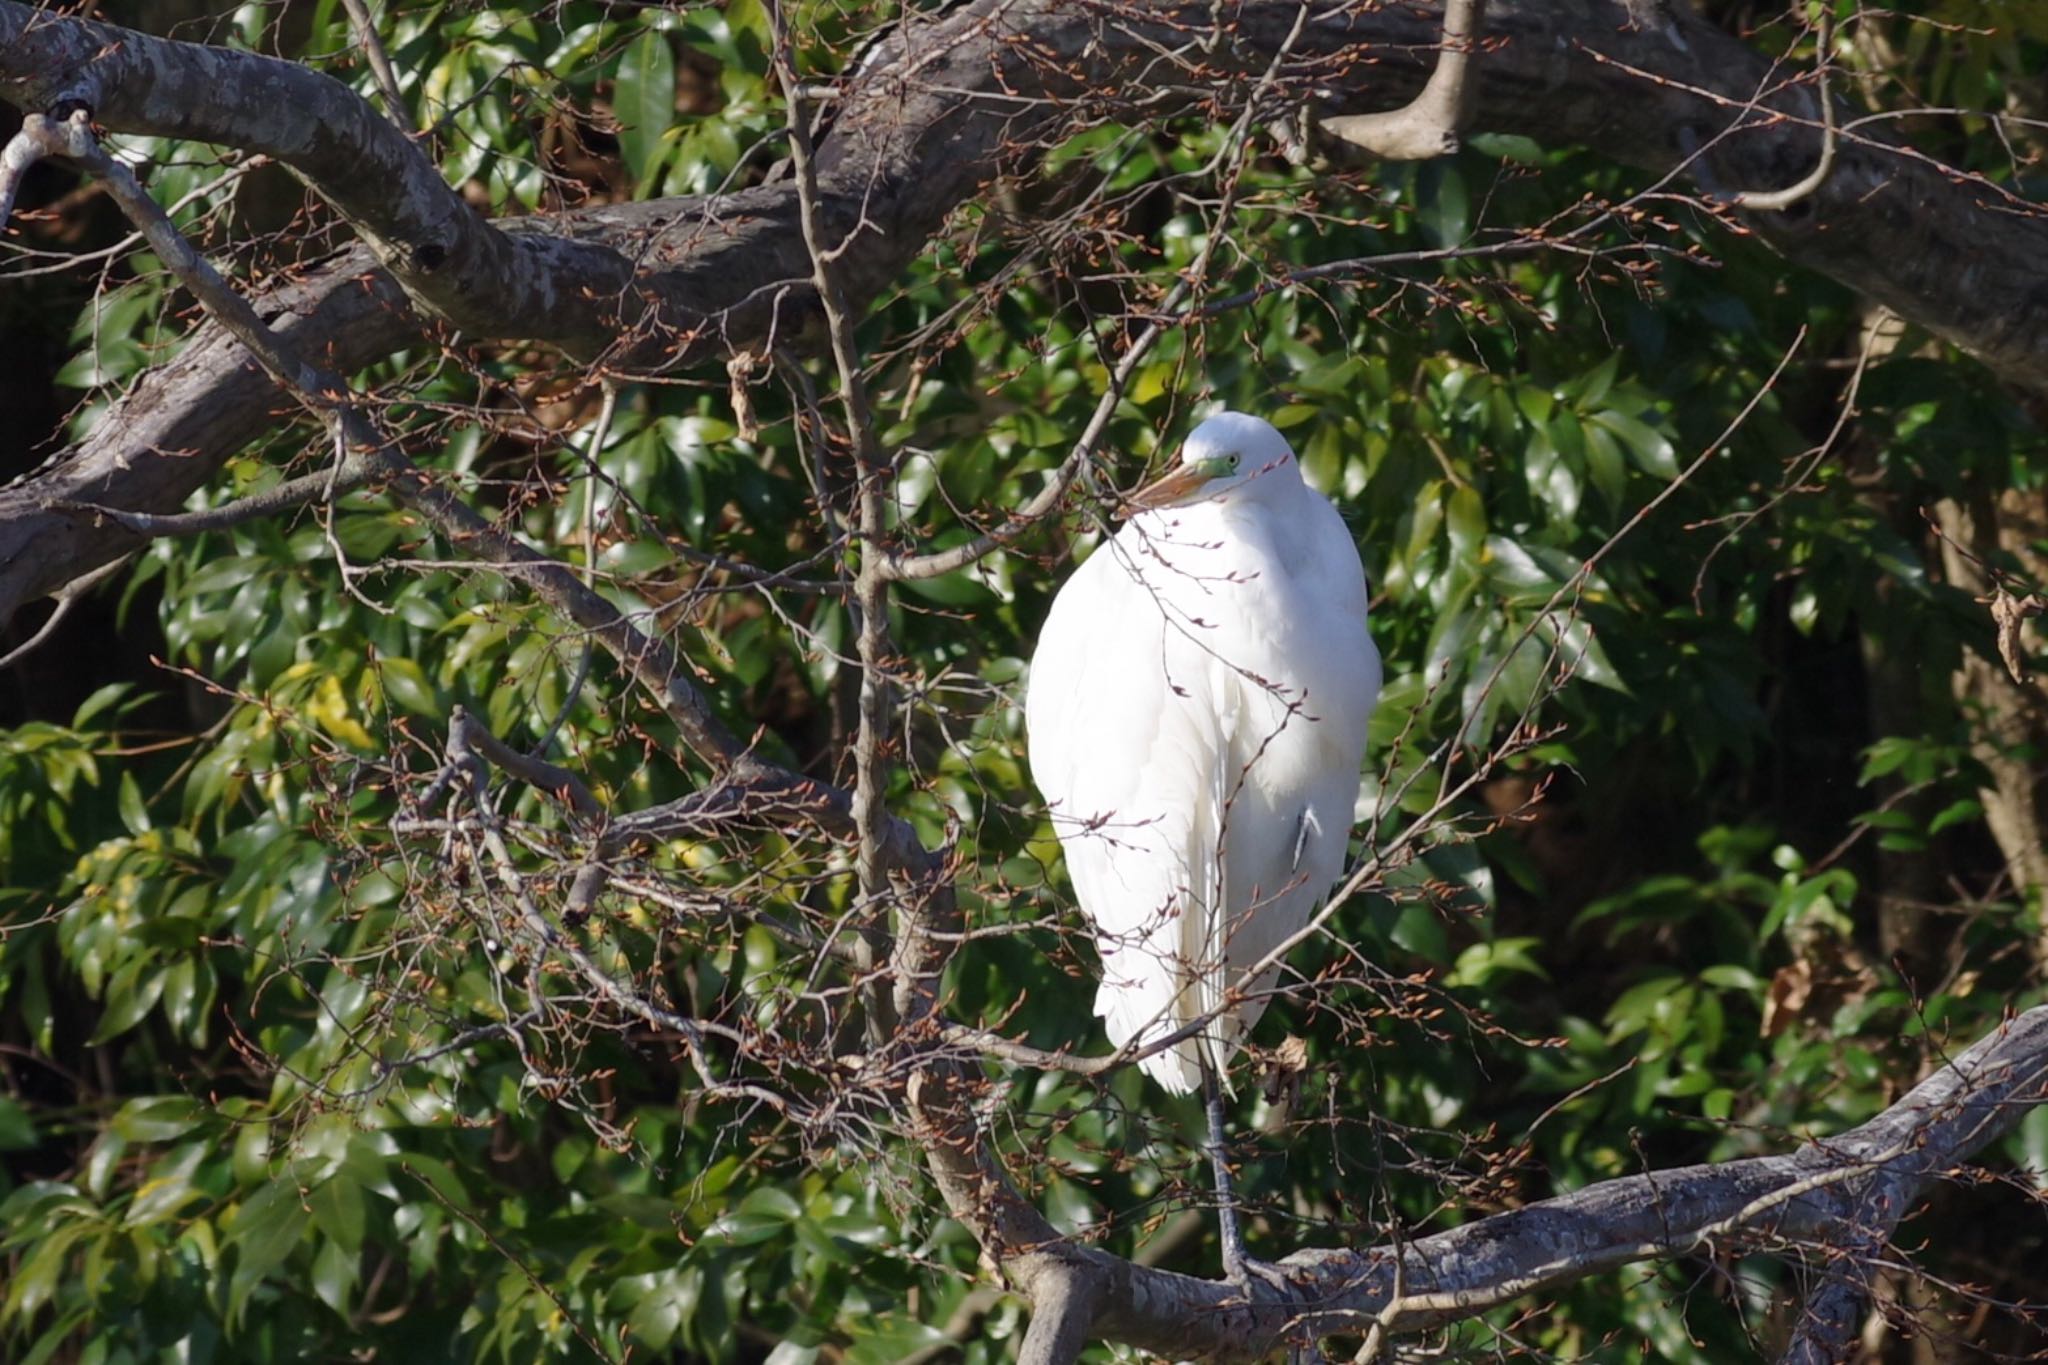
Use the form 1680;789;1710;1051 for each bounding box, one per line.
0;0;2048;1365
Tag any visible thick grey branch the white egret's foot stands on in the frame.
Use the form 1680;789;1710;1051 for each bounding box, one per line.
1038;1007;2048;1361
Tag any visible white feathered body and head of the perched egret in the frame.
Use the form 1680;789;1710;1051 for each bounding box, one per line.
1024;413;1380;1093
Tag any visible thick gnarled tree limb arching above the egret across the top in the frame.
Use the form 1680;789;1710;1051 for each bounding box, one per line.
0;0;2048;618
